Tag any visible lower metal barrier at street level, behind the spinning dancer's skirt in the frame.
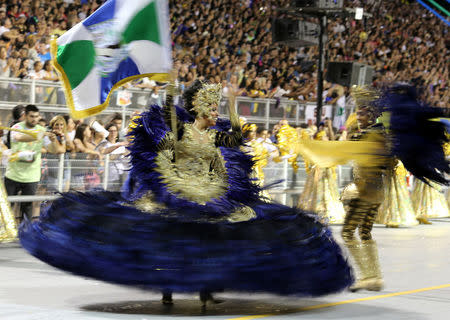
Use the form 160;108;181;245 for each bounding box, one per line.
0;153;352;205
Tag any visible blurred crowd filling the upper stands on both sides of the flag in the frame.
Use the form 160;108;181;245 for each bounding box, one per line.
0;0;450;106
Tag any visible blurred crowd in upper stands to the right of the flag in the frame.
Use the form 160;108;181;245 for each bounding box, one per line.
171;0;449;106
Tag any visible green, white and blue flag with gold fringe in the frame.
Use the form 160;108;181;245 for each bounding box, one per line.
51;0;172;119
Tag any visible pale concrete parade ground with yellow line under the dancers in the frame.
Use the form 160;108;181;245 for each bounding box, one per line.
0;219;450;320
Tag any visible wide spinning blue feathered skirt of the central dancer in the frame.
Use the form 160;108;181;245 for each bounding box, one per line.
19;192;353;296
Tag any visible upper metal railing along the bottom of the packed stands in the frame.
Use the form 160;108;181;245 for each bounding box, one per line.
0;77;351;129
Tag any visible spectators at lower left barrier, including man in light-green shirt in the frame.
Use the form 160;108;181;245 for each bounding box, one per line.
0;104;128;219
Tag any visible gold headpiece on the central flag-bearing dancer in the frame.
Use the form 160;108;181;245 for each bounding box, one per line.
190;83;222;118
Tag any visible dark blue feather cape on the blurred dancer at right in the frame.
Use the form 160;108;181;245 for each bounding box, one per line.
375;84;450;185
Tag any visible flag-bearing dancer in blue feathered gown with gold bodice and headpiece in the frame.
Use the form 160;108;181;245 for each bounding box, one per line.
20;81;353;304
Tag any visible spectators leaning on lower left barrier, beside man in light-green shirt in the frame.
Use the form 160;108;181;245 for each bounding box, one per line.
0;105;129;193
